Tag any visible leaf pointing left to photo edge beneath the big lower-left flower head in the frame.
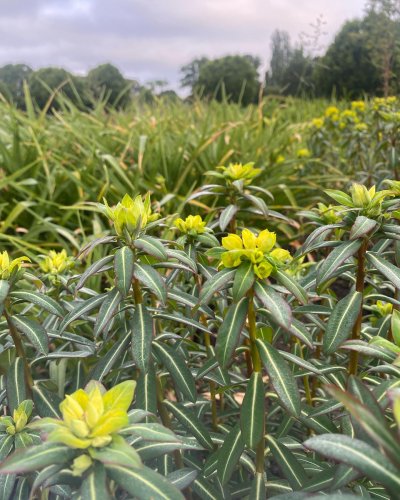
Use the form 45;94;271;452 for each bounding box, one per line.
0;443;76;474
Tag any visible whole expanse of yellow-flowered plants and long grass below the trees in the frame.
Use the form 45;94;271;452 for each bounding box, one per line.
0;91;400;500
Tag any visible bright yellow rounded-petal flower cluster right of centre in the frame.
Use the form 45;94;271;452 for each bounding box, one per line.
221;229;291;279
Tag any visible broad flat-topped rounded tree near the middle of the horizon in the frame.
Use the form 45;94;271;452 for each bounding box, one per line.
192;55;260;105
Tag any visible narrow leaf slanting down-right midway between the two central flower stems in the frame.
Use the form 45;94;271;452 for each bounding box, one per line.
153;342;197;403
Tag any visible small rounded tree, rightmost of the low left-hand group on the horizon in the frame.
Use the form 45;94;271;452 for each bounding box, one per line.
87;64;130;107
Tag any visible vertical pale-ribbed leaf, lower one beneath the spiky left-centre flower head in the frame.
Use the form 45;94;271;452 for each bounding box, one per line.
131;304;154;372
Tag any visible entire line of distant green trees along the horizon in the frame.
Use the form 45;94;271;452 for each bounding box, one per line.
0;0;400;109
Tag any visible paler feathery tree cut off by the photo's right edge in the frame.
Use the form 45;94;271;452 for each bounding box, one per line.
364;0;400;97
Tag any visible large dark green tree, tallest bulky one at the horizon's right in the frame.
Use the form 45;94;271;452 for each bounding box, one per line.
314;20;380;98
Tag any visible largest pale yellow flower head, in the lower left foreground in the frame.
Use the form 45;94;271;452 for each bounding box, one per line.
36;380;136;452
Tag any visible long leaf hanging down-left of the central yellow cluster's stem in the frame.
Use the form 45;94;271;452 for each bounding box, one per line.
215;297;249;368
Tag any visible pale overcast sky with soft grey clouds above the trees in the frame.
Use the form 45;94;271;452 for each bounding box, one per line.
0;0;365;87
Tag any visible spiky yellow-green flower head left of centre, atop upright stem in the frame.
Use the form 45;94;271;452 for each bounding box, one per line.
104;193;159;236
